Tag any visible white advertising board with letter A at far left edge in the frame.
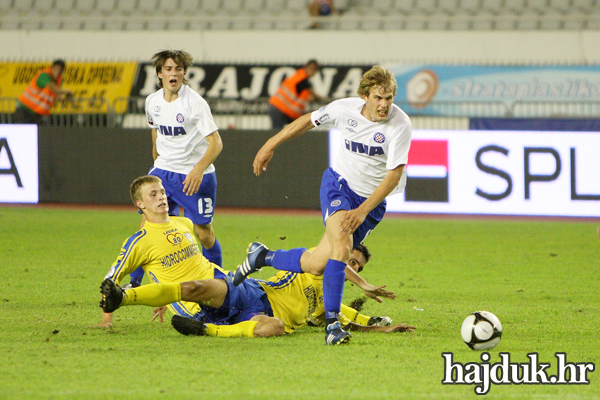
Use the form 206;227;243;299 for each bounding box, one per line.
0;125;39;203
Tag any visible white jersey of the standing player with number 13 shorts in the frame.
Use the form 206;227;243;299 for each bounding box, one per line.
146;85;218;174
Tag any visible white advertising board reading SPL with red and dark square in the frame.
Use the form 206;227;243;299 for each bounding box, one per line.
330;130;600;217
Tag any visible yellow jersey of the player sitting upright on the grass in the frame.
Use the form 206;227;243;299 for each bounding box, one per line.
106;217;227;316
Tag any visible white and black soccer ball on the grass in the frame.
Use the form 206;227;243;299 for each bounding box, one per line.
460;311;502;350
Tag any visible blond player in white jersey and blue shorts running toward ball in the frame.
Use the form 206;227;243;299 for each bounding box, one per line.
234;66;412;345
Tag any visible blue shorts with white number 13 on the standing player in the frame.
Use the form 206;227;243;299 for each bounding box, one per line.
148;167;217;225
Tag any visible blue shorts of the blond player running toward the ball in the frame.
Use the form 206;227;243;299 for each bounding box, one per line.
320;168;387;247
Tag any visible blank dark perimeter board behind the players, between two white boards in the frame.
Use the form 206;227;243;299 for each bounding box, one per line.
38;127;329;209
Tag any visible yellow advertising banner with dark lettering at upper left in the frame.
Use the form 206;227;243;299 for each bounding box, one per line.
0;60;138;114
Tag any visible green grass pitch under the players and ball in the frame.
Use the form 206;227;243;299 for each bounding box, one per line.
0;205;600;399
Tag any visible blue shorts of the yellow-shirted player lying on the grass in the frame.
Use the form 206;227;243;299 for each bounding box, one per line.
203;273;273;325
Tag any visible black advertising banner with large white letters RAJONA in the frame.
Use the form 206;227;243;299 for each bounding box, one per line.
131;63;370;112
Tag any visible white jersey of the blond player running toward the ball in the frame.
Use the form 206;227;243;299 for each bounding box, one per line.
311;97;412;197
